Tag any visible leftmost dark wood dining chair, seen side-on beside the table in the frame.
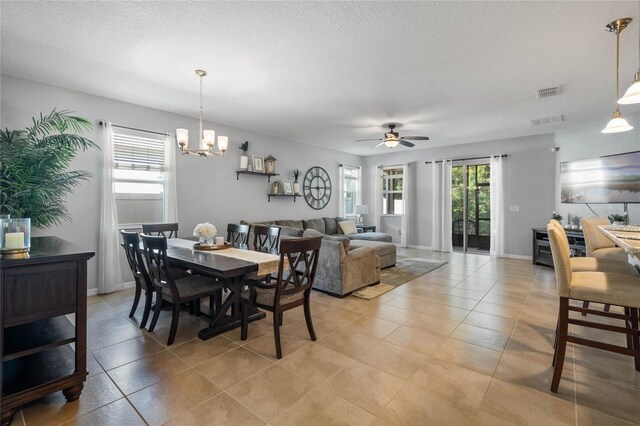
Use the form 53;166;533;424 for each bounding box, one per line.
120;231;155;328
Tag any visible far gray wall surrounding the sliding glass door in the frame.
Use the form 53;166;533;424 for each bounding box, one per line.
364;135;555;257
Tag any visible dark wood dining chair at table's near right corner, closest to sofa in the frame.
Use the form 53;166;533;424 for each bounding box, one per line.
241;237;322;359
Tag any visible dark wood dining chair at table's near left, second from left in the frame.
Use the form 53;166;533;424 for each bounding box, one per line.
140;234;222;345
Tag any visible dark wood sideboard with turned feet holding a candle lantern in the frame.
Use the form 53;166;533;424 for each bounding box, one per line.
0;237;95;426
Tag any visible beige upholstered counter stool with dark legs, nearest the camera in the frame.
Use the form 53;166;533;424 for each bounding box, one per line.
547;224;640;392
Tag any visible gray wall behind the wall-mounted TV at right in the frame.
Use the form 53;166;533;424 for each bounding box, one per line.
555;111;640;224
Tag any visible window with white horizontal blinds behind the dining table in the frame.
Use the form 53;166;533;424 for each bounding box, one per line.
113;131;167;227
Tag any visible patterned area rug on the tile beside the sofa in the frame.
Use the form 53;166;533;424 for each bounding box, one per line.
352;258;447;300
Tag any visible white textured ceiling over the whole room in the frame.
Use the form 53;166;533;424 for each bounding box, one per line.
1;1;640;155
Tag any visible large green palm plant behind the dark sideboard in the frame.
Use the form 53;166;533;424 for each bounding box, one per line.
0;109;100;228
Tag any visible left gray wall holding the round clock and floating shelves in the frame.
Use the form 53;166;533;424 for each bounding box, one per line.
0;75;361;288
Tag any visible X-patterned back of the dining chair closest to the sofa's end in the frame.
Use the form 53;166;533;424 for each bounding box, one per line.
275;236;322;301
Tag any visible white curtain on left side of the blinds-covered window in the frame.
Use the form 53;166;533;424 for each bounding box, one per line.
98;122;123;293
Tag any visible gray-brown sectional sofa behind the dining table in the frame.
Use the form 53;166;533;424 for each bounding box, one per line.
241;217;396;297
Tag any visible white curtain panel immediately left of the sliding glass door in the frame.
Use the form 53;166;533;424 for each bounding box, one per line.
431;160;453;252
